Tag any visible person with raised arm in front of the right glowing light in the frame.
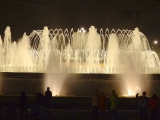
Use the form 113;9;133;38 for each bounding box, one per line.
136;92;148;120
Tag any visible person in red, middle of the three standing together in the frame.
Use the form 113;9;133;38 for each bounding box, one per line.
99;92;106;119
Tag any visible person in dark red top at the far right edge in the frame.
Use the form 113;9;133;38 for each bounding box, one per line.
149;94;158;120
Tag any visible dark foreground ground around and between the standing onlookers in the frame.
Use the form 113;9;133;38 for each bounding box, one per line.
0;96;160;120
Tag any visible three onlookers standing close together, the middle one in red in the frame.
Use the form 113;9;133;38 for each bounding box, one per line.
92;89;118;119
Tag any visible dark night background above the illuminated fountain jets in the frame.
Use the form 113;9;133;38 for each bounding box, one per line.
0;0;160;54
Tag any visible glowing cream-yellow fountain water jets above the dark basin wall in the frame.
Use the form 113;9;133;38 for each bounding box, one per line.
0;26;160;74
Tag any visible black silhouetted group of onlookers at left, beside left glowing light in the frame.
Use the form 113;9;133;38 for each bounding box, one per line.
19;87;52;118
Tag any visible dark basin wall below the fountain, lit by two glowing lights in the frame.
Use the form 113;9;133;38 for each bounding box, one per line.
0;72;160;96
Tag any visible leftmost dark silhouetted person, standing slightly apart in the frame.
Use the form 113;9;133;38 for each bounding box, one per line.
19;92;28;117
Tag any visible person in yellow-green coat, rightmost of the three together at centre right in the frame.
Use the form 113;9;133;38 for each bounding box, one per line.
109;90;118;119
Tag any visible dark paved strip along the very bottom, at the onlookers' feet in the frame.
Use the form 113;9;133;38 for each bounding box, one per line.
0;109;160;120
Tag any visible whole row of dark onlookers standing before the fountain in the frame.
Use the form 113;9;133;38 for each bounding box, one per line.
19;87;158;120
